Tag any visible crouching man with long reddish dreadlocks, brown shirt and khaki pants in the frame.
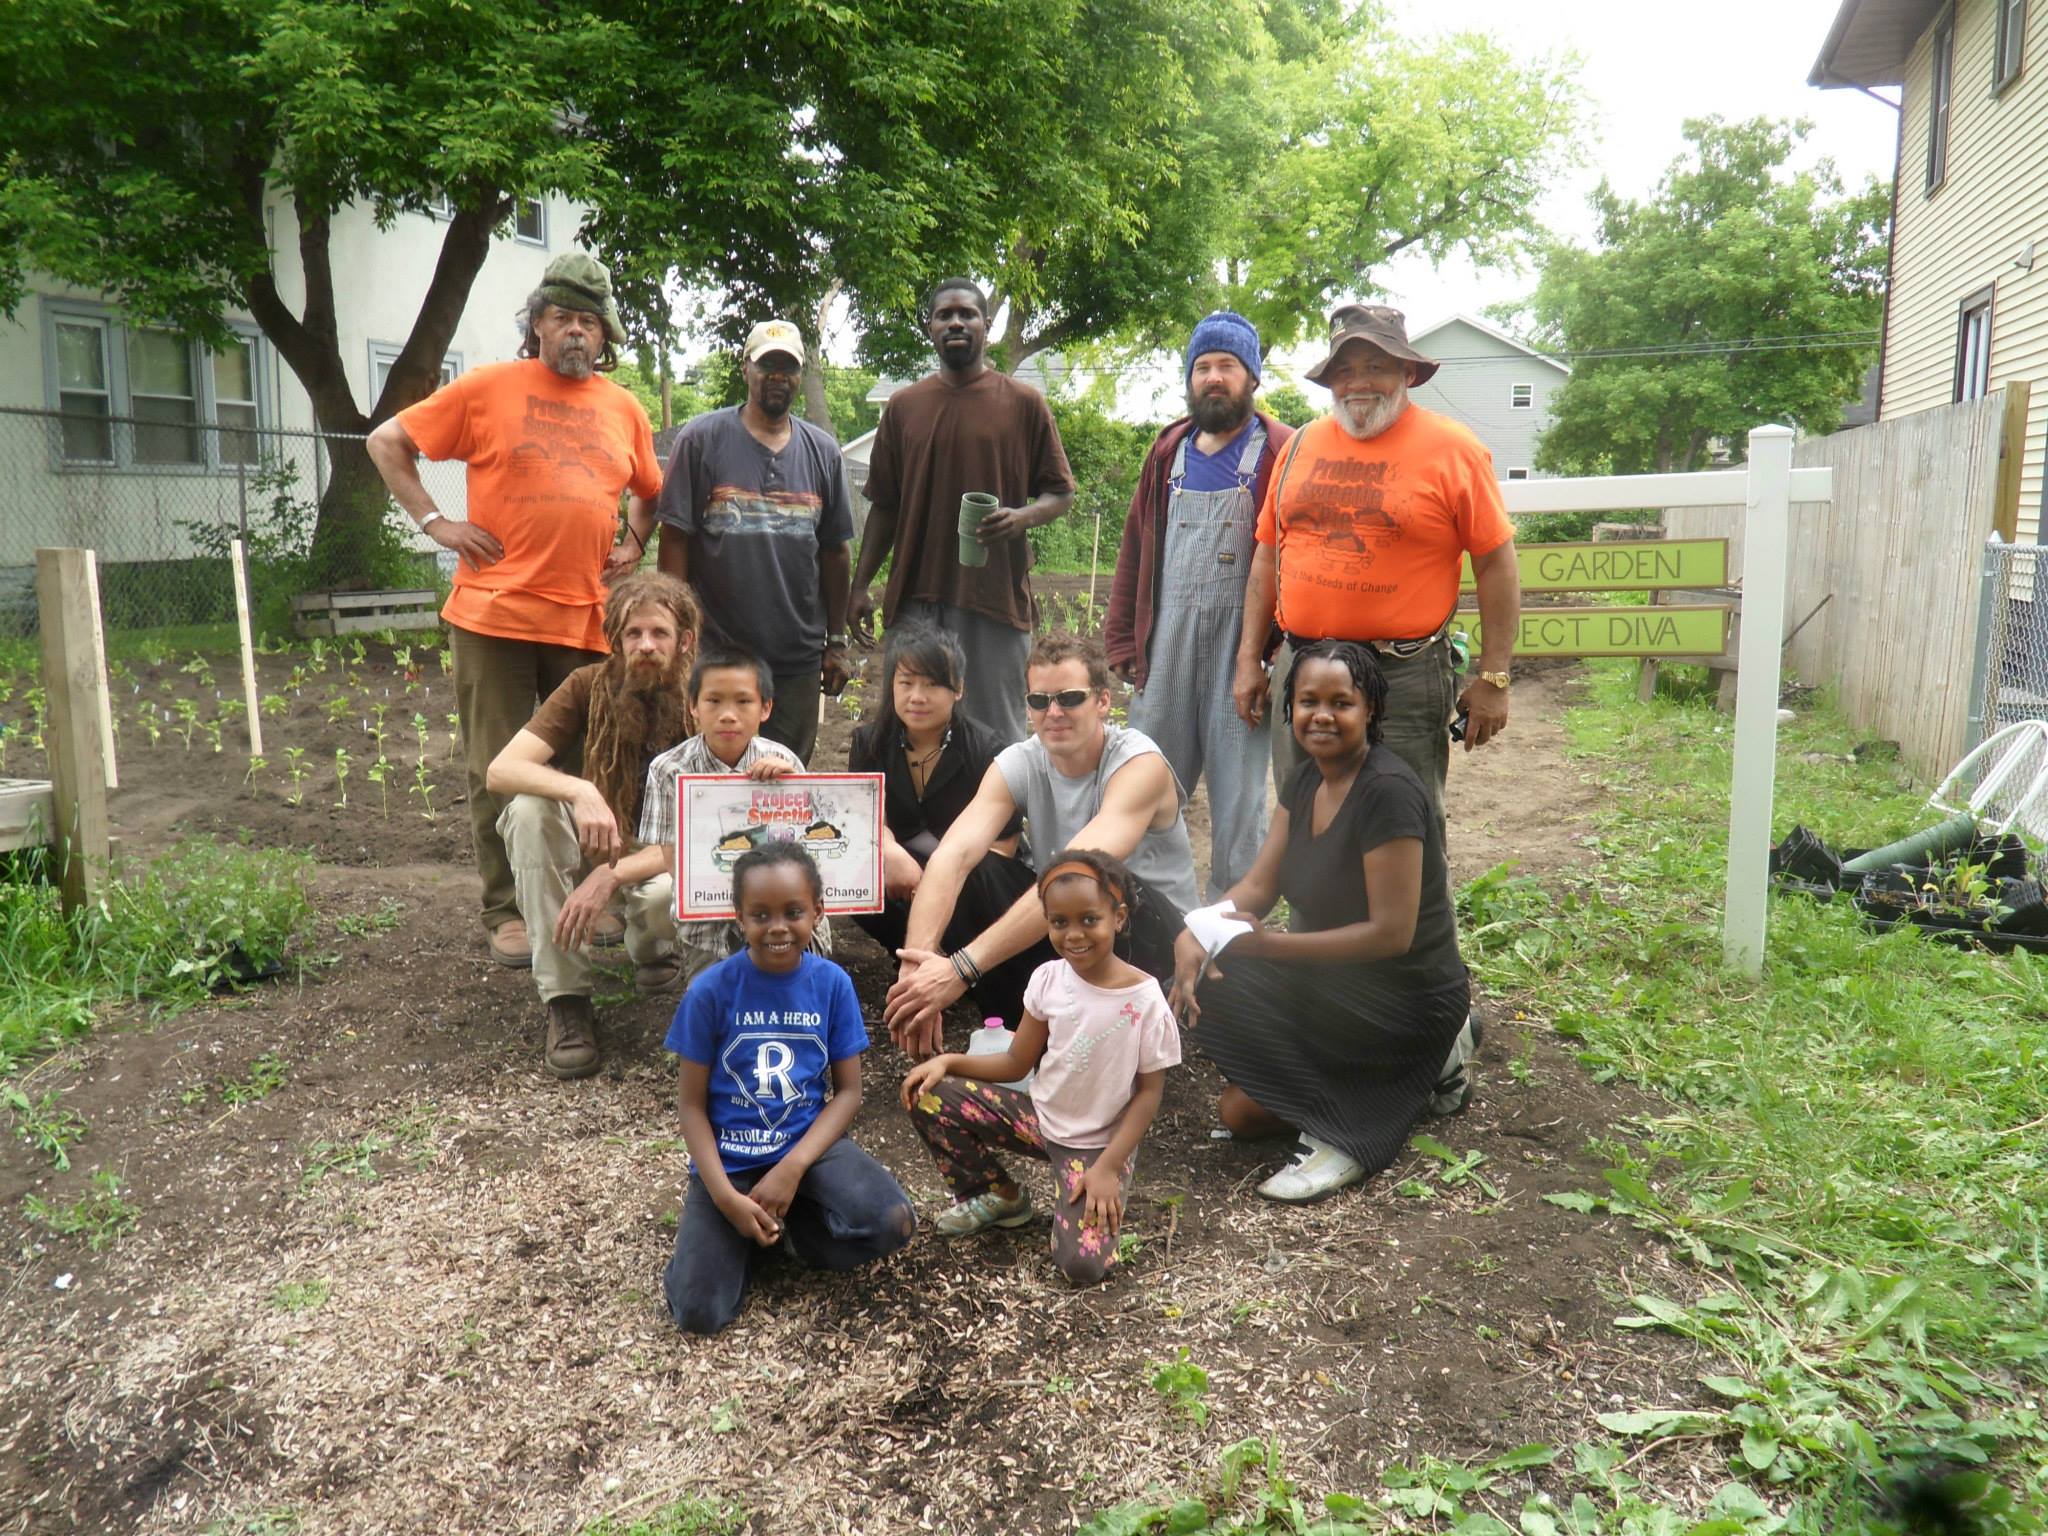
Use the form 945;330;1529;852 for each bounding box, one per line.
485;571;698;1077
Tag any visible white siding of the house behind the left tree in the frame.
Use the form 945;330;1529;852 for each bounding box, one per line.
0;197;582;567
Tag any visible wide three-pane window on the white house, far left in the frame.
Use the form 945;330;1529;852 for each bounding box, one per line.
43;299;262;469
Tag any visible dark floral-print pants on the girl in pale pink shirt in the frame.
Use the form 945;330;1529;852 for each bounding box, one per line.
909;1077;1137;1286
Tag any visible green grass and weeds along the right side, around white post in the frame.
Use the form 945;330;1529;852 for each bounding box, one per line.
1081;664;2048;1536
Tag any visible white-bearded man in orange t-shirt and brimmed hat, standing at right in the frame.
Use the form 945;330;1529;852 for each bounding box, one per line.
1233;305;1522;821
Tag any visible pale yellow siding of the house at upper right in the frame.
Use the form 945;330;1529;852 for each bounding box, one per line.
1882;0;2048;539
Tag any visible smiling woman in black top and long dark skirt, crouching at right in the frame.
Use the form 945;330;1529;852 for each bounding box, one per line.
1174;641;1470;1204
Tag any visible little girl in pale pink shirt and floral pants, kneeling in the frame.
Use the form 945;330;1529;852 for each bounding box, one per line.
903;848;1180;1286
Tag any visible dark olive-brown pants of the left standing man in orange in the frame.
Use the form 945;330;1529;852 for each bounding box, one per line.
449;625;604;932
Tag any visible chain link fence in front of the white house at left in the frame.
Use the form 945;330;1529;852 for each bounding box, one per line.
0;408;467;641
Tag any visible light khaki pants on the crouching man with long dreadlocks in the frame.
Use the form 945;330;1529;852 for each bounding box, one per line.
496;795;684;1004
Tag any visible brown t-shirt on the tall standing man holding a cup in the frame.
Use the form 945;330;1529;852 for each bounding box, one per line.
866;369;1073;631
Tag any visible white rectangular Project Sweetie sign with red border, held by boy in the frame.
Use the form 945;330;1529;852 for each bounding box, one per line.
676;774;885;922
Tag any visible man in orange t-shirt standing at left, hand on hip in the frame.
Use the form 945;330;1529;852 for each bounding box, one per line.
369;252;662;967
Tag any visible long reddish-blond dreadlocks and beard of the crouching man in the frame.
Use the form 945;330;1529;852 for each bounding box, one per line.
584;571;702;838
